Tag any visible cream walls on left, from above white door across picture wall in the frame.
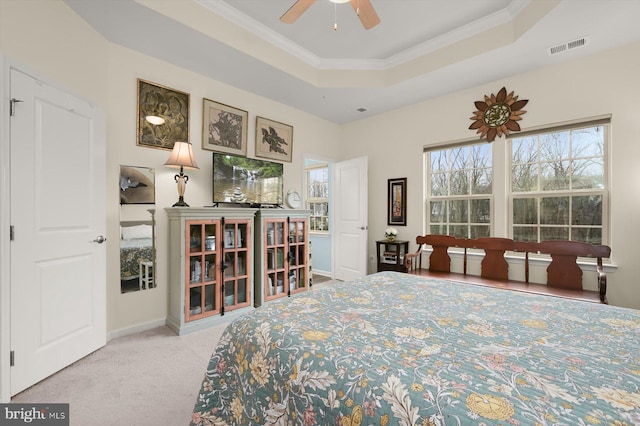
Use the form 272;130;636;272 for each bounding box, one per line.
0;0;340;336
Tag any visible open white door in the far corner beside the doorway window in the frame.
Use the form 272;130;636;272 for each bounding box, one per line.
332;157;368;281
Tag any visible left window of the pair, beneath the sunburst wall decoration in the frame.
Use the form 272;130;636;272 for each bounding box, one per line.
427;142;493;238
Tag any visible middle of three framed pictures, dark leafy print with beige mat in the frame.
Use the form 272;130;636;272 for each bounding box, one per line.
202;98;249;157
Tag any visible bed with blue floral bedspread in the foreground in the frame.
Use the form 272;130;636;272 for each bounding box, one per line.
191;272;640;426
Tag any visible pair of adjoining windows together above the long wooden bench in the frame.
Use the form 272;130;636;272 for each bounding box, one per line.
425;118;610;244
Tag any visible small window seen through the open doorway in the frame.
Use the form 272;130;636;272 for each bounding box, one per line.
305;163;329;233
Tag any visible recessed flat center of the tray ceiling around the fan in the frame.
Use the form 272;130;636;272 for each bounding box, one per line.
205;0;523;62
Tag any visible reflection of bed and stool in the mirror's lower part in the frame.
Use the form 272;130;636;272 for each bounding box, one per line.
120;216;156;293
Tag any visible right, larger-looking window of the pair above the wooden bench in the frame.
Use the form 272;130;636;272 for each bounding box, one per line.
511;125;608;244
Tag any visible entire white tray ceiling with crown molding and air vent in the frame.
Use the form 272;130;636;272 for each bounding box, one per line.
65;0;640;123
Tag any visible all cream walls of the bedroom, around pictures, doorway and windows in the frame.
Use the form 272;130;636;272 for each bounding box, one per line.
0;0;640;342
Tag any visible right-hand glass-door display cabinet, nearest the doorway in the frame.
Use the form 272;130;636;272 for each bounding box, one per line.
254;209;311;307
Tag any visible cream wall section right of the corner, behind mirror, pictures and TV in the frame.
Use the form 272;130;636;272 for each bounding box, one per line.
107;45;339;331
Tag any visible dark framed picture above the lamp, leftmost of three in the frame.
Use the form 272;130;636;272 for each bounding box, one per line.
136;78;189;150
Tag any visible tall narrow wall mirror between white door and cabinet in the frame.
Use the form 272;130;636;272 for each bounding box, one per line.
120;166;156;293
